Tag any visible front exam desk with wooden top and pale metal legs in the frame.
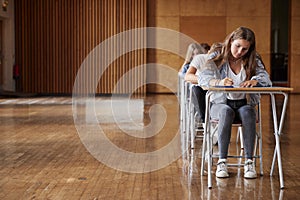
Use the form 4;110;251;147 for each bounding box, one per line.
203;86;293;189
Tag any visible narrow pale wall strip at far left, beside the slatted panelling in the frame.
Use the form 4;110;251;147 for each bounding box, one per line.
0;0;15;91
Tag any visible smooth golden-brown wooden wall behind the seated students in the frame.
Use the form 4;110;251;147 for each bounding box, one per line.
148;0;274;93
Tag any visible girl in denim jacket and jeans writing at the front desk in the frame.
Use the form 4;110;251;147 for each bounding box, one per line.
198;27;272;178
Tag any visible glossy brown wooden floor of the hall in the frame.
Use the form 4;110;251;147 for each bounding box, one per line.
0;95;300;200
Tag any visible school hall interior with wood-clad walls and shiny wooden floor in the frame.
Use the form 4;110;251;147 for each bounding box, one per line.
0;0;300;200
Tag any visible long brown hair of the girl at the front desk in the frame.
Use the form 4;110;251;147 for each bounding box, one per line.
214;27;257;80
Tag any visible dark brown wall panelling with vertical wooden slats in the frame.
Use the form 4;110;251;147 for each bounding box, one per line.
15;0;146;94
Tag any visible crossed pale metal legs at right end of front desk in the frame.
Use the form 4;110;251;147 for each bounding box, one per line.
270;94;288;189
